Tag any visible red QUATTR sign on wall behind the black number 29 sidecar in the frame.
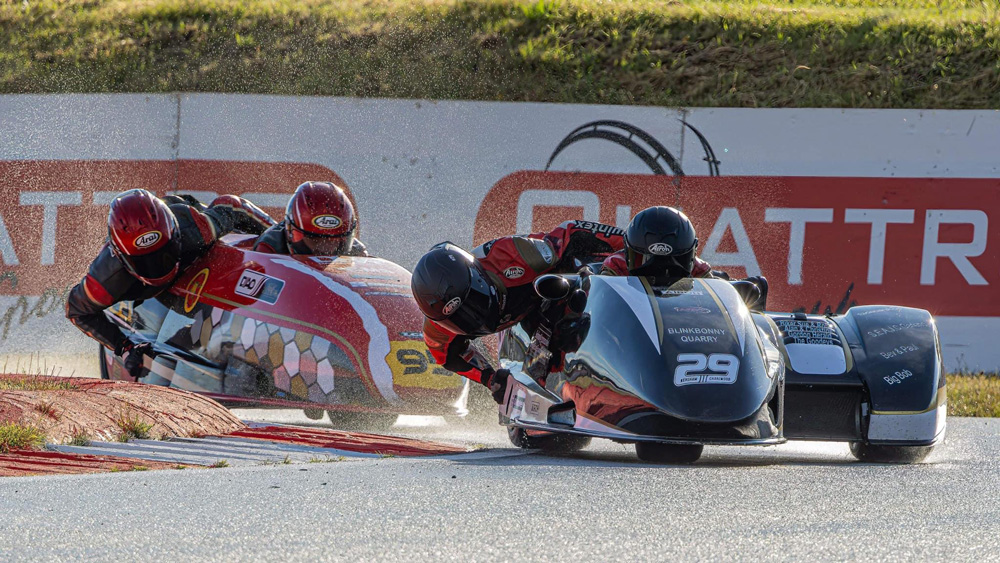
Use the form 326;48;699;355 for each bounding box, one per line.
474;171;1000;317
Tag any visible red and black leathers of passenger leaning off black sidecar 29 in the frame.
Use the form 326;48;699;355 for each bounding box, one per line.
424;221;625;384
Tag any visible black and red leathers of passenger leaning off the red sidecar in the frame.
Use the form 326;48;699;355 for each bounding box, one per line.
66;195;274;350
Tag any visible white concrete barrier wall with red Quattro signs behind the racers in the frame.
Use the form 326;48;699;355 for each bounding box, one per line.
0;94;1000;370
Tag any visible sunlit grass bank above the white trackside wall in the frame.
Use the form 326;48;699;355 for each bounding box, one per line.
0;0;1000;108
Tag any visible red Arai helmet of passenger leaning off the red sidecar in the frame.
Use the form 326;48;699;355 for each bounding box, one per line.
108;190;181;286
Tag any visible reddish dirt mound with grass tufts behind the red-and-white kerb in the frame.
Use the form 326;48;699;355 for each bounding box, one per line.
0;375;245;443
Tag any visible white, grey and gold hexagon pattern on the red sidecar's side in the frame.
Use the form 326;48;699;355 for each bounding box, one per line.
191;307;362;404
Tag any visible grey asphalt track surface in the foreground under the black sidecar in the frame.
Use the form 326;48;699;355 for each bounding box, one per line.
0;415;1000;561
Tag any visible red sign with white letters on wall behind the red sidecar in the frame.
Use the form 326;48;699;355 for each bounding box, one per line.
0;160;346;295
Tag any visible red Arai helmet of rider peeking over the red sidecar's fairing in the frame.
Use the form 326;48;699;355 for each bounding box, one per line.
285;182;358;256
